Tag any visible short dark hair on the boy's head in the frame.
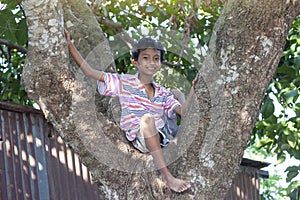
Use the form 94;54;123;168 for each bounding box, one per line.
131;37;165;62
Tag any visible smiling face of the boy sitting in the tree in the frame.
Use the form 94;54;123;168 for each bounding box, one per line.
132;48;161;76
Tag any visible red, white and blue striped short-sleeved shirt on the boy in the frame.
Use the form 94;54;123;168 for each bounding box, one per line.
98;73;180;141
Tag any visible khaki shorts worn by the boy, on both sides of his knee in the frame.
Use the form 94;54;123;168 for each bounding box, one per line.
131;125;176;153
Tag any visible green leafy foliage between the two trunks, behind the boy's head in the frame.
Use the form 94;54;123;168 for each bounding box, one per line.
96;0;220;92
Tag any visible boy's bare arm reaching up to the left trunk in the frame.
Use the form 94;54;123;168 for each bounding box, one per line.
64;30;104;82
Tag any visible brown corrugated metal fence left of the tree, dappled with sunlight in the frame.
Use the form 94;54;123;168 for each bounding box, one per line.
0;102;101;200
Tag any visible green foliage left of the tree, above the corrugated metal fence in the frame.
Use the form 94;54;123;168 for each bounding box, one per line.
0;1;33;105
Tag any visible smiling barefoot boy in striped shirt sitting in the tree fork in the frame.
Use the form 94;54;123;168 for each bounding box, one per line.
65;30;193;192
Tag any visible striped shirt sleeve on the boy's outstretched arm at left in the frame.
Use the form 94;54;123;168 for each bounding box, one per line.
98;73;120;97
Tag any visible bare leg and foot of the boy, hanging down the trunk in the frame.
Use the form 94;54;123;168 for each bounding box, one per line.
140;114;190;192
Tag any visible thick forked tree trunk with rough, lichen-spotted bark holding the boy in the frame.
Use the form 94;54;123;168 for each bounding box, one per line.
23;0;300;200
